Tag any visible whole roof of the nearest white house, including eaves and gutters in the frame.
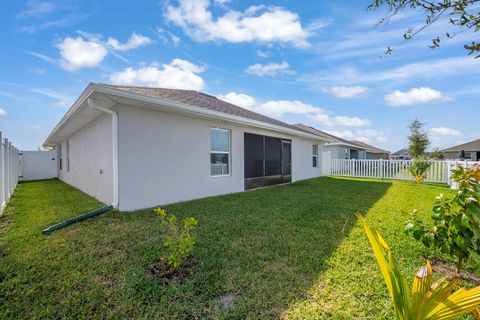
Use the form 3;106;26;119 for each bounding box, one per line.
43;83;328;147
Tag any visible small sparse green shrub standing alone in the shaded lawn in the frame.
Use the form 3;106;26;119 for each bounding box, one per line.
154;208;197;269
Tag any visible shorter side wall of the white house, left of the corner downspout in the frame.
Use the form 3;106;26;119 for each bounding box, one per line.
57;114;113;204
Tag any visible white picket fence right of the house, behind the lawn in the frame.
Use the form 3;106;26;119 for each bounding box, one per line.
330;159;456;184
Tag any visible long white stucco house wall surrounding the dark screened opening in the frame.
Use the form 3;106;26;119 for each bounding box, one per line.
119;106;322;210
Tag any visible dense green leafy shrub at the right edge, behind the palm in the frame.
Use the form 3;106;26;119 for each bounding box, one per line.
405;164;480;271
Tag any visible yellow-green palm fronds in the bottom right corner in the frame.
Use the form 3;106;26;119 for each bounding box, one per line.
357;213;480;320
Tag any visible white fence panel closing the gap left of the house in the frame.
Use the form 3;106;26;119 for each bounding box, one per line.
21;151;57;181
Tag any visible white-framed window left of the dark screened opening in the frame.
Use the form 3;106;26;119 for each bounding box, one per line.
210;128;231;176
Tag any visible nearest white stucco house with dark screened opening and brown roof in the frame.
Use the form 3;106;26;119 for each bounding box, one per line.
44;83;328;210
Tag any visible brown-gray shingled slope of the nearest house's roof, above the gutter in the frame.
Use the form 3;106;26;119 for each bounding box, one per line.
102;84;310;133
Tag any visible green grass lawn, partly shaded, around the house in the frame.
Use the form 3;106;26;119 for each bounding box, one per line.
0;178;479;319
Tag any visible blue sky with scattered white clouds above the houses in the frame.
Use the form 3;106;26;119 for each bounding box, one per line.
0;0;480;151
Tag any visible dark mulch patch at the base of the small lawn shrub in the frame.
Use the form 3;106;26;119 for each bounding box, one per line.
147;257;198;283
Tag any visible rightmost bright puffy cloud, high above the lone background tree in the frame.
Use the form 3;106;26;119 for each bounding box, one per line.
385;87;445;107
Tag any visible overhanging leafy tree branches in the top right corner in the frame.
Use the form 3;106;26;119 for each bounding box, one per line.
368;0;480;58
